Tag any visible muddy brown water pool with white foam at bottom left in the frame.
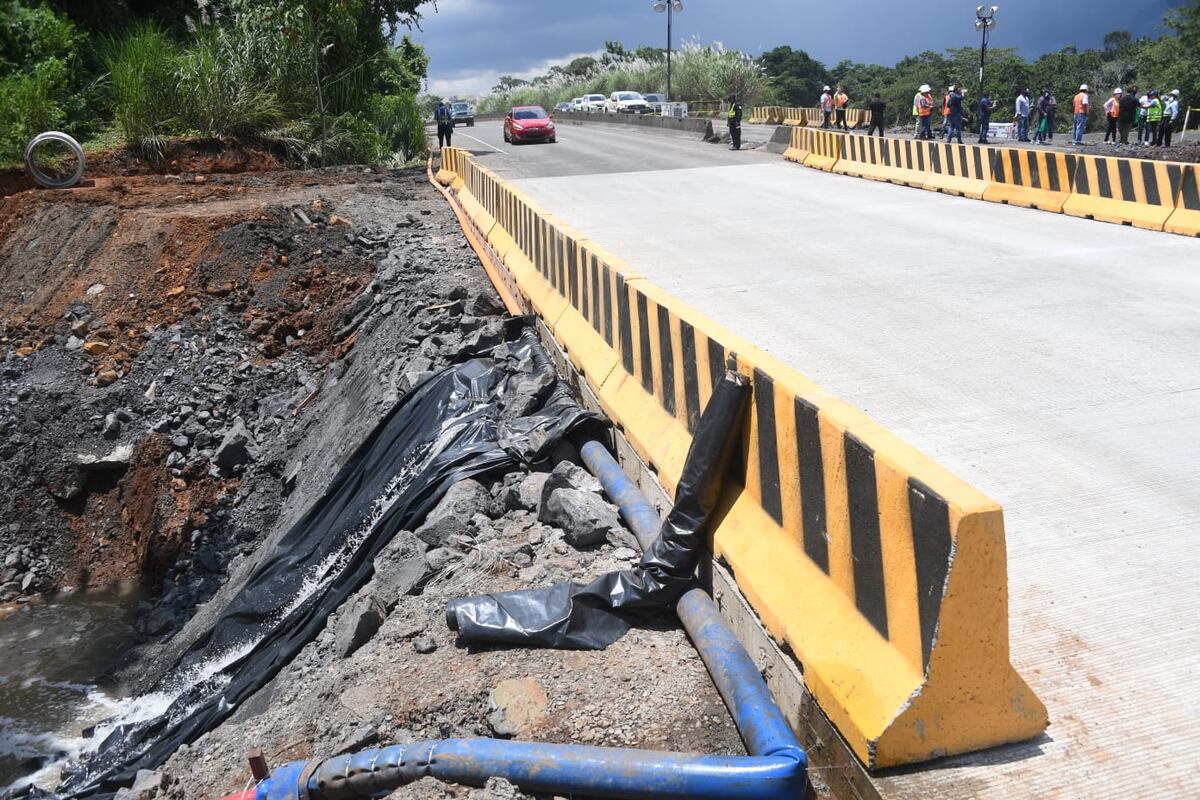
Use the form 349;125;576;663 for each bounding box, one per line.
0;589;140;792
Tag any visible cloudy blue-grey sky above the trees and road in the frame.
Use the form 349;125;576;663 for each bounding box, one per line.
415;0;1178;95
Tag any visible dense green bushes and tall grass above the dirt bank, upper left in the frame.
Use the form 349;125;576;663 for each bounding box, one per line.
0;0;428;163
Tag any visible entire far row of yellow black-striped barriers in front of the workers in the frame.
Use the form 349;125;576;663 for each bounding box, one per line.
784;127;1200;236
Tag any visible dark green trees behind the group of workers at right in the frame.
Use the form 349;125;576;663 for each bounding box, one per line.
760;0;1200;130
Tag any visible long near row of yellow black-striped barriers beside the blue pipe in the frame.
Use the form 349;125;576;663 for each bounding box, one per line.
443;146;1046;768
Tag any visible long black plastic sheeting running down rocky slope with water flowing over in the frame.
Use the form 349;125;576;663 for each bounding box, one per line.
45;318;604;798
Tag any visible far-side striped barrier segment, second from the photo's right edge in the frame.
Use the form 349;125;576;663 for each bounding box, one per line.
1062;156;1183;230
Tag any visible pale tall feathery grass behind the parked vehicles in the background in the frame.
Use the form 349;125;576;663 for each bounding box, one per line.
479;41;767;113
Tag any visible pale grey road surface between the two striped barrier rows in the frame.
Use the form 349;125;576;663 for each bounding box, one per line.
446;124;1200;798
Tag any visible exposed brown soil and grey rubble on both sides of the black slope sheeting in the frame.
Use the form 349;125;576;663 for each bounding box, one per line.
0;151;743;800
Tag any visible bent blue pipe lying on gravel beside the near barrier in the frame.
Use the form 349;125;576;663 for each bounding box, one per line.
243;441;808;800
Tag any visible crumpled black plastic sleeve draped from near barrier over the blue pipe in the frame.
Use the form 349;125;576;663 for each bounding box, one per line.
446;372;750;650
